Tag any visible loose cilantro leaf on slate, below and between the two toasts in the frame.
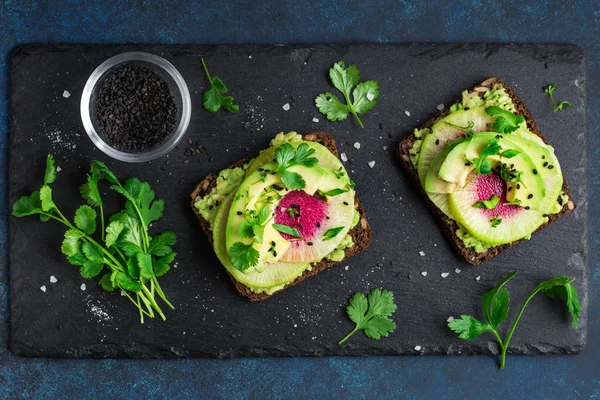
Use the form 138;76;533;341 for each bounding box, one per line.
338;289;397;344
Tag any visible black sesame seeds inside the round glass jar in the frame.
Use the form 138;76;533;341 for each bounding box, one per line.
96;66;177;152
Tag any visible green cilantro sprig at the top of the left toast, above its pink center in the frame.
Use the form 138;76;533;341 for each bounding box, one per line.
275;143;319;190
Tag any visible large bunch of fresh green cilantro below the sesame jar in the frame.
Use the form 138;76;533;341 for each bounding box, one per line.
13;154;176;323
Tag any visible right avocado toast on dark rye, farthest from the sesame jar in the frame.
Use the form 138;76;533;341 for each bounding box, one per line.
397;77;575;265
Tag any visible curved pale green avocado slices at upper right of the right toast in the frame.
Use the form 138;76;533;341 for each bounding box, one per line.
466;132;546;213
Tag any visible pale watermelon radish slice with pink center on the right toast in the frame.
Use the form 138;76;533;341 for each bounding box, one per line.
448;174;548;245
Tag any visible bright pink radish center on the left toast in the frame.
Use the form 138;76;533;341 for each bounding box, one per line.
275;190;327;240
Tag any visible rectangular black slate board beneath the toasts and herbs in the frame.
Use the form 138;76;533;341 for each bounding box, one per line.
10;44;588;358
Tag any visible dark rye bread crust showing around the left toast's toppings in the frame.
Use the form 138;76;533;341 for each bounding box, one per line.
190;132;371;301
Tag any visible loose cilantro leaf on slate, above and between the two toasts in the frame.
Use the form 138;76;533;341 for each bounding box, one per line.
315;61;379;128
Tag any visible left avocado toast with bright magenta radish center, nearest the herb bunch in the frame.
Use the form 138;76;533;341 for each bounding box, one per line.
191;132;371;301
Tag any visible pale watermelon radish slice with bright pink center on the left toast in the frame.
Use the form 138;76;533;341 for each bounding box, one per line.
275;190;354;263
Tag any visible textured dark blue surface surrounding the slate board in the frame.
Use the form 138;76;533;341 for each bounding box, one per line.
0;0;600;399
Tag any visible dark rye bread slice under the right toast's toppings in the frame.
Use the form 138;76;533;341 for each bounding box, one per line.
396;77;575;265
